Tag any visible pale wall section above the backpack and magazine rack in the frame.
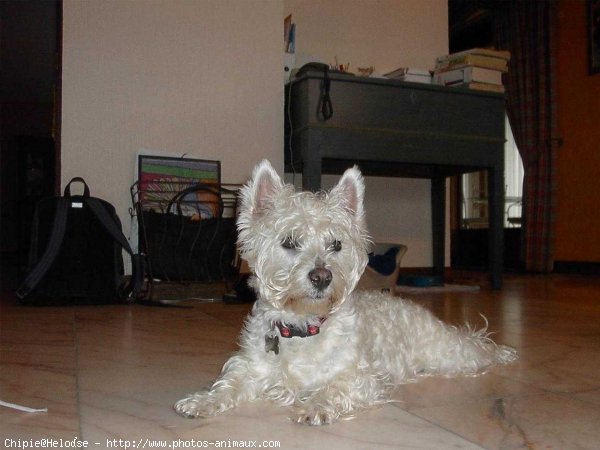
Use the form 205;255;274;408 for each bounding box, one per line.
62;0;283;227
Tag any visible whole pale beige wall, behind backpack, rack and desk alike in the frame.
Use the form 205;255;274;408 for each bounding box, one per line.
61;0;448;266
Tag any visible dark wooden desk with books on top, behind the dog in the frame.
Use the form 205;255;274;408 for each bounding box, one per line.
285;71;504;289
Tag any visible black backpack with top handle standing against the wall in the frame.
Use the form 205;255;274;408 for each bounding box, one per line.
16;177;144;304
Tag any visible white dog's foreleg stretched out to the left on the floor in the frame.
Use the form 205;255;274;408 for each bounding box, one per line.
174;355;256;418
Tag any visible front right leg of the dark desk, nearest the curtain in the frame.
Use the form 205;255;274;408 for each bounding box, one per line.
488;165;504;289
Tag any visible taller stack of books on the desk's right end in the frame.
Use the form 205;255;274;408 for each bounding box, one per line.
433;48;510;92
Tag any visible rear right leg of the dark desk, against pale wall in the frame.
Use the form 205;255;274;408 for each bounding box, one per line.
431;177;446;277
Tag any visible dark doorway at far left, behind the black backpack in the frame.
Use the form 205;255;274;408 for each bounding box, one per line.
0;0;62;270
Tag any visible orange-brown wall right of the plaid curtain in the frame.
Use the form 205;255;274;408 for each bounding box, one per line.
555;0;600;262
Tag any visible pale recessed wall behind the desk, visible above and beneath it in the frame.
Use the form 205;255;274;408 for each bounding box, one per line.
284;0;449;267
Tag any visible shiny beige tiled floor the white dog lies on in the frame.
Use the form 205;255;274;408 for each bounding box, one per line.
0;276;600;450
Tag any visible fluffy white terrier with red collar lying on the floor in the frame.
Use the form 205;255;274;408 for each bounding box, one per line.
175;161;516;425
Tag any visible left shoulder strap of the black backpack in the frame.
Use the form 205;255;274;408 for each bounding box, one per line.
16;198;71;300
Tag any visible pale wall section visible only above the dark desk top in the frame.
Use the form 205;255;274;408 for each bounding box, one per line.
283;0;448;73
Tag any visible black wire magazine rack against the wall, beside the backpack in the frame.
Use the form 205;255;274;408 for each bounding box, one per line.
131;180;240;288
